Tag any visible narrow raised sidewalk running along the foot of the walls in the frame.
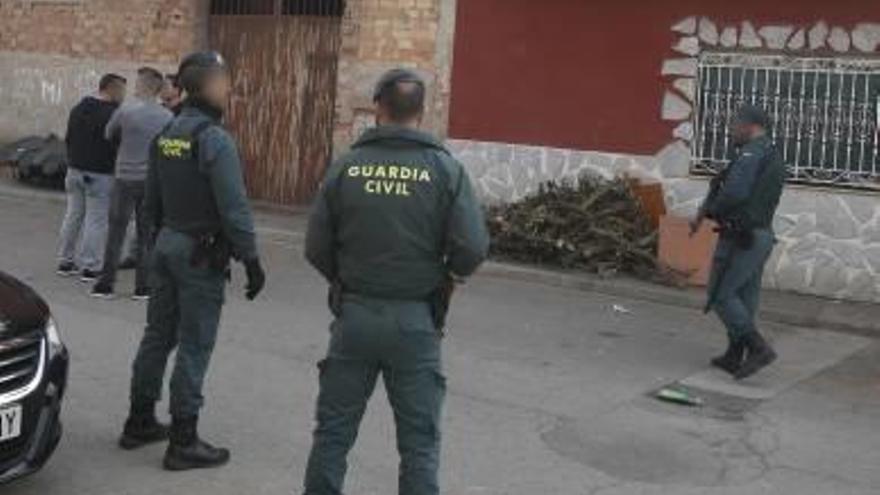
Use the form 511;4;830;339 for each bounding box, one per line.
0;174;880;337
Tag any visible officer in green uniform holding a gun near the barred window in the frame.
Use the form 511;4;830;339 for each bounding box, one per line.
691;105;786;380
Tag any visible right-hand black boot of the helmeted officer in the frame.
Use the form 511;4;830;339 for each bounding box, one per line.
163;417;229;471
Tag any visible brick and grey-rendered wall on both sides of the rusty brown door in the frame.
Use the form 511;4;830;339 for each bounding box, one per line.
0;0;464;157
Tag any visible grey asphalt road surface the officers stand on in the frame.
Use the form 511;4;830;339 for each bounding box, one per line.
0;197;880;495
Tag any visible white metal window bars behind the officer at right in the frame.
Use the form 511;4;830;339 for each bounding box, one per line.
692;52;880;190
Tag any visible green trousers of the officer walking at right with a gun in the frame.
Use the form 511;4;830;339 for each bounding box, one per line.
709;229;775;340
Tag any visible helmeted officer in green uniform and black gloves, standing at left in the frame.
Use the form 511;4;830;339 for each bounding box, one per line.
120;52;265;470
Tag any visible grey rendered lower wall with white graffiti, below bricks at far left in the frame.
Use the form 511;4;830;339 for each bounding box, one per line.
0;51;173;142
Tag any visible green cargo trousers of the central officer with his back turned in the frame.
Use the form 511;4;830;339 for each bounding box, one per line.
305;296;446;495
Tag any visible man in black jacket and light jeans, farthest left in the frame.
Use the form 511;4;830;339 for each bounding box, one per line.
58;74;126;282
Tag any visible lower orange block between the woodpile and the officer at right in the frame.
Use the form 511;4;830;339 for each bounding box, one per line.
658;215;718;286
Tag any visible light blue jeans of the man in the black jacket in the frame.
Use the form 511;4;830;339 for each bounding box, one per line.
58;168;113;272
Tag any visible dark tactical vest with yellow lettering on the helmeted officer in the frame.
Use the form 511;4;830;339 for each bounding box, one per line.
153;121;221;235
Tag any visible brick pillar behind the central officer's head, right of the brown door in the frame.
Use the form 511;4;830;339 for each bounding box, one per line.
334;0;456;153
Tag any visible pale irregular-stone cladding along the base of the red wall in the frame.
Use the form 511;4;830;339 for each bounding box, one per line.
448;140;880;302
